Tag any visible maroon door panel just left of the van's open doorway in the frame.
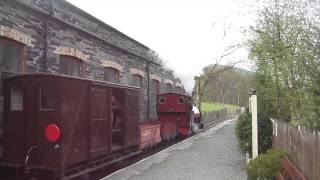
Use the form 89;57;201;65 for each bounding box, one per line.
89;86;111;158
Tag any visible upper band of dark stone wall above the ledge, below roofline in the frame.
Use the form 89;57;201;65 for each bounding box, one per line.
17;0;154;59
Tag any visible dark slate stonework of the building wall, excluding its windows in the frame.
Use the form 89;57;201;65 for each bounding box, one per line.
0;0;185;125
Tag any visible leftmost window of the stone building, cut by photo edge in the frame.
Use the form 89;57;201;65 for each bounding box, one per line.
0;38;24;72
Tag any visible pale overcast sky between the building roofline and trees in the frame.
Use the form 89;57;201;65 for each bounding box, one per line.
68;0;255;92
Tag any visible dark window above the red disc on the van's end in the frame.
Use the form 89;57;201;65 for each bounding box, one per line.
40;85;56;110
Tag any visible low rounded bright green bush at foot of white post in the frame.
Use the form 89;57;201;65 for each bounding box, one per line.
247;150;286;180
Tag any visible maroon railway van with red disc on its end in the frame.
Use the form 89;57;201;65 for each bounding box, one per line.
0;74;139;179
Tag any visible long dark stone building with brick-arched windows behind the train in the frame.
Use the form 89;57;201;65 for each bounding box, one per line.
0;0;184;138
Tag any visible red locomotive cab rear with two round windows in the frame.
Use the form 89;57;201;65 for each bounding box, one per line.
157;93;192;140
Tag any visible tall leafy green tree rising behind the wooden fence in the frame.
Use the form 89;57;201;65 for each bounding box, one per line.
248;0;320;129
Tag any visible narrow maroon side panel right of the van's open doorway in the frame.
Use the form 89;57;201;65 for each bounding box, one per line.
125;90;140;148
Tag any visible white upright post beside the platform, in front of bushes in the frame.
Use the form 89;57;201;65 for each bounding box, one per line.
249;90;258;159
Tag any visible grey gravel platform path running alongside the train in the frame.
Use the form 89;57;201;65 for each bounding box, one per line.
103;117;247;180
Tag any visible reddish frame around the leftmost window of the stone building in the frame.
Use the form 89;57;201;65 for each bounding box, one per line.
0;36;27;73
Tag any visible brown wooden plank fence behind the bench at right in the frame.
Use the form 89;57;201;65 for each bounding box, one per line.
272;120;320;180
